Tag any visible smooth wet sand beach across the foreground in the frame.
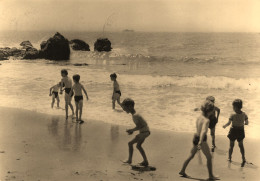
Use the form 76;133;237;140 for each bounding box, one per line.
0;107;260;181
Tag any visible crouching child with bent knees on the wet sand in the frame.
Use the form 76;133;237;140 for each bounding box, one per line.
122;99;150;166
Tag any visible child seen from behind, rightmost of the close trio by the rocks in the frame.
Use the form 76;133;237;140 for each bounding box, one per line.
69;74;88;124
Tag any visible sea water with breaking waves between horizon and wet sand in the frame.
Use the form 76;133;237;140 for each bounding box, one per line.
0;32;260;139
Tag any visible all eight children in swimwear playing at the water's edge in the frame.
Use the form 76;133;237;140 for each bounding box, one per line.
50;69;248;180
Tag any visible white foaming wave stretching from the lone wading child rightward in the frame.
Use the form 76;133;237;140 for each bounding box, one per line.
119;75;260;91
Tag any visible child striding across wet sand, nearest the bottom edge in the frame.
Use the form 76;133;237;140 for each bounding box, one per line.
179;101;217;180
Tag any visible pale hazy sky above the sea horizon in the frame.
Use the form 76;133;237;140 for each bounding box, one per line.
0;0;260;32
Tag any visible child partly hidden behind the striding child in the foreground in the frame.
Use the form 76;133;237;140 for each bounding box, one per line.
206;96;220;152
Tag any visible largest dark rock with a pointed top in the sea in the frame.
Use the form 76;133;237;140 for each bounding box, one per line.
39;32;70;60
